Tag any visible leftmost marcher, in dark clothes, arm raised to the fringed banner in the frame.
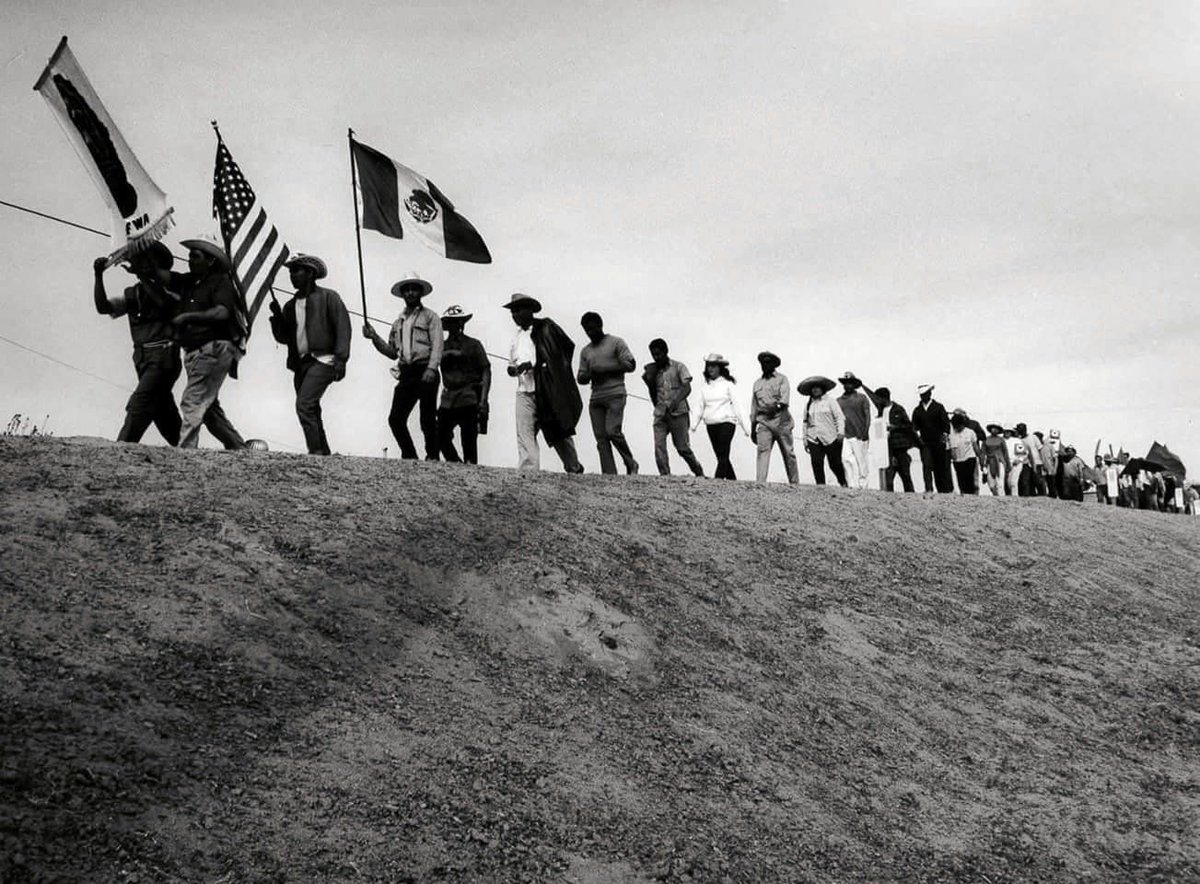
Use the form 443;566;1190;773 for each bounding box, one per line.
92;242;182;445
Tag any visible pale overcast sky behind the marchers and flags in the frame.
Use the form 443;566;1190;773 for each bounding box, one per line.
0;0;1200;480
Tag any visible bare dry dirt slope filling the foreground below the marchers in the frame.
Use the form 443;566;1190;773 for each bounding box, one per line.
0;439;1200;882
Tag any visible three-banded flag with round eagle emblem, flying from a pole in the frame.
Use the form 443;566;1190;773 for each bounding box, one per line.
352;136;492;264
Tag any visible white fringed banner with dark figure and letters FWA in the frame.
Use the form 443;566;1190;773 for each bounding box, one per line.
34;37;173;264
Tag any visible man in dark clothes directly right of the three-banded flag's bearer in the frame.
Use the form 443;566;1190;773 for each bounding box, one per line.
438;303;492;463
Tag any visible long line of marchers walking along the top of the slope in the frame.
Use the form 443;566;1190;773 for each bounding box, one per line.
94;244;1196;513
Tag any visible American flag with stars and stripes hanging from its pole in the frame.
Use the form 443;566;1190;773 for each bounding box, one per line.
212;126;290;335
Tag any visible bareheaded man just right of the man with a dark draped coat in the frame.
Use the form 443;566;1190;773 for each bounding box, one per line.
575;311;637;476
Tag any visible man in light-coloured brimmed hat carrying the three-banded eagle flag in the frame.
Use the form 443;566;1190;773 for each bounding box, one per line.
362;273;443;461
